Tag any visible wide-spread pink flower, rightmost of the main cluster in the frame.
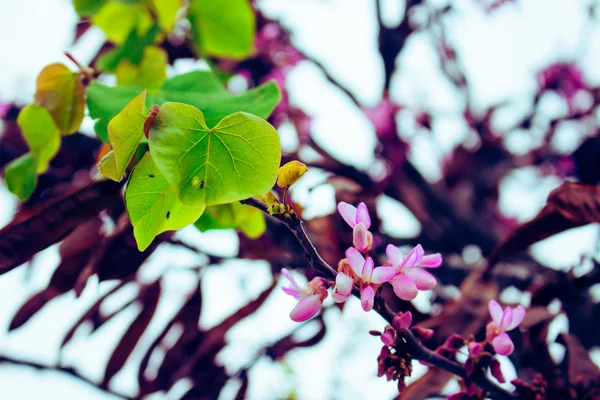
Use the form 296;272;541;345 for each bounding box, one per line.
386;244;442;301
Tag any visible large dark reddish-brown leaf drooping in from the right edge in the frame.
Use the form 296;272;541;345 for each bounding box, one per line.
488;182;600;267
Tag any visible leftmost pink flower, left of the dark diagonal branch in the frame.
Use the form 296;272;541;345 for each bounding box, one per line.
281;268;327;322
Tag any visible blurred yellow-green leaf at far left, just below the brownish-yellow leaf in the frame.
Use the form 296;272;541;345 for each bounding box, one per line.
17;104;60;174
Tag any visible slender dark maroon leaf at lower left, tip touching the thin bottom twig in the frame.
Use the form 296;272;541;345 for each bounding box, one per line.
100;280;161;387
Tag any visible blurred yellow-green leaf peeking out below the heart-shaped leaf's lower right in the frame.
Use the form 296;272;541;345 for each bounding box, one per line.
194;201;267;238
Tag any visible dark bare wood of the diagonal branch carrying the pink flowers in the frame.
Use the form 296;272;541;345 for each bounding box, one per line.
241;198;518;400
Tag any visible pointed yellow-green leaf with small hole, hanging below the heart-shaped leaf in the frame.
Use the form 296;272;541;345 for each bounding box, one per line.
125;153;205;251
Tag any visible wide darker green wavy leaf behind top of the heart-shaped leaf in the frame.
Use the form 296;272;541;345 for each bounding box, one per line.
87;71;281;142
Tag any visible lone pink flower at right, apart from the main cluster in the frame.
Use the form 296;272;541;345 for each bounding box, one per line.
486;300;525;356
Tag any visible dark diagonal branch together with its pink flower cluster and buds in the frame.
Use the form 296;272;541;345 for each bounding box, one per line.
241;191;520;400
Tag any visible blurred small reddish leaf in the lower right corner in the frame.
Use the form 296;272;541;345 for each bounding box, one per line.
556;333;600;385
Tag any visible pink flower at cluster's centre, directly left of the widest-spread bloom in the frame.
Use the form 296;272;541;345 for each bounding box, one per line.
338;247;395;311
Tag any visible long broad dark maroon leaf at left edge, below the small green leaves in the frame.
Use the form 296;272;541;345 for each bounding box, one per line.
0;180;121;274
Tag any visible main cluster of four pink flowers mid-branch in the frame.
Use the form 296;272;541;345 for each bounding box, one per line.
283;202;442;321
